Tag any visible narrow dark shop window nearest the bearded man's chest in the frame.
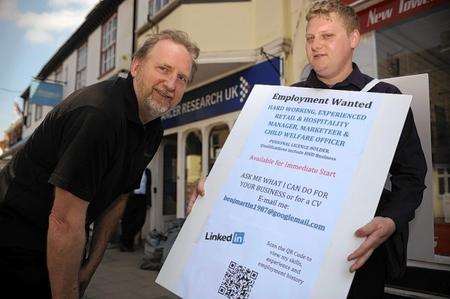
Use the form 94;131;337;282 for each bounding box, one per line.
162;134;177;215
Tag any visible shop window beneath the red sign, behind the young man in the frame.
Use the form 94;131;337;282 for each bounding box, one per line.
376;6;450;256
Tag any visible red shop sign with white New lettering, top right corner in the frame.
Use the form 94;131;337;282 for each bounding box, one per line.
356;0;449;33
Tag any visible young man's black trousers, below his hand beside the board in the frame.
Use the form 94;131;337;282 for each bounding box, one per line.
347;246;387;299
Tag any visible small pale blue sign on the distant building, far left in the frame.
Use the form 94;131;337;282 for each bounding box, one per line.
30;80;63;106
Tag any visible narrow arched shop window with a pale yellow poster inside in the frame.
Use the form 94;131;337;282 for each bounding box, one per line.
185;131;202;214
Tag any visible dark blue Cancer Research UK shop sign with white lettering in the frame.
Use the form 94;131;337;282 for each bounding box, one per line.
162;58;281;129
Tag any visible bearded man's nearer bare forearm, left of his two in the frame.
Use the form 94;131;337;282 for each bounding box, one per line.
47;214;85;298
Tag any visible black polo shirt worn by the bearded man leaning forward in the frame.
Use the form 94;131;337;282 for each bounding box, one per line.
0;75;163;250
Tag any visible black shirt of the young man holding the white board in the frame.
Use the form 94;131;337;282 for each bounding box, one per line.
293;63;427;277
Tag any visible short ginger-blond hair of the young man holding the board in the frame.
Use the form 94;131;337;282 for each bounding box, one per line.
306;0;359;33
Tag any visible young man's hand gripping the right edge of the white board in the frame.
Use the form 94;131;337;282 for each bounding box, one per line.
347;217;395;272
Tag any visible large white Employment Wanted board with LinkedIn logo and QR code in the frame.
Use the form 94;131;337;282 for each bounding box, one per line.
156;85;411;298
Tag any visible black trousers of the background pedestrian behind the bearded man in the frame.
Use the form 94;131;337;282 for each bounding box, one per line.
120;194;147;248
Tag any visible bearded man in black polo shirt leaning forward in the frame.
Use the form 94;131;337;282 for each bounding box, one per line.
0;31;199;298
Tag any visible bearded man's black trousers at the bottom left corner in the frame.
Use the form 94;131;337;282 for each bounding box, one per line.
0;247;52;298
